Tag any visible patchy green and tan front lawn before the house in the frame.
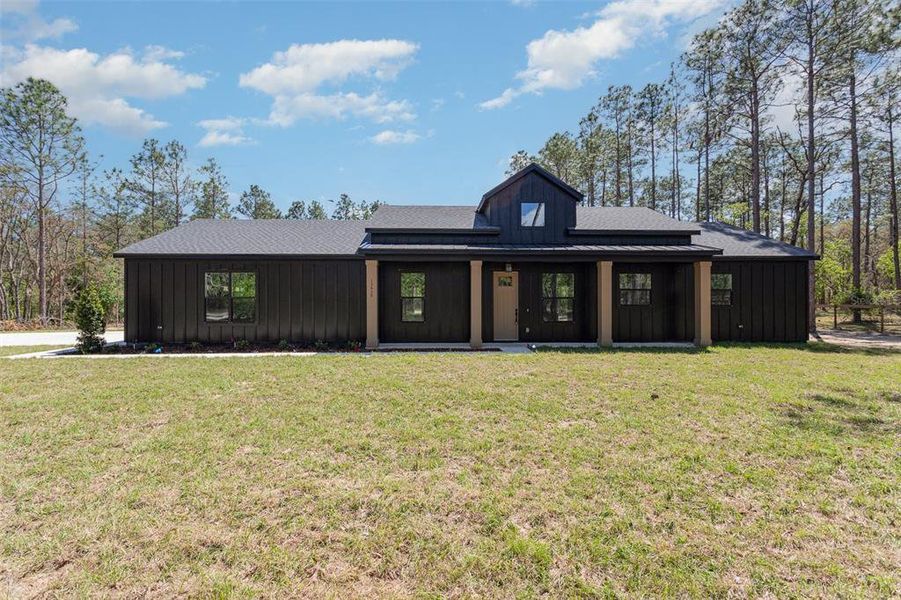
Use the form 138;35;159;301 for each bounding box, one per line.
0;347;901;598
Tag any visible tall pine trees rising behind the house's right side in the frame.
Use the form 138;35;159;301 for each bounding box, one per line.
509;0;901;325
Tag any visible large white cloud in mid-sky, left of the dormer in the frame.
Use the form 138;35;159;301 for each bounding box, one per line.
239;40;419;126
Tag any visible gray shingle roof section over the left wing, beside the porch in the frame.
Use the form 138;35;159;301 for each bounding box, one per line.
116;219;367;256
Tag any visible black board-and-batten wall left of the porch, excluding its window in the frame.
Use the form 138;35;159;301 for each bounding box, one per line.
125;259;366;344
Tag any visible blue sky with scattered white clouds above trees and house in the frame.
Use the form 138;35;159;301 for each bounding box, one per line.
0;0;725;209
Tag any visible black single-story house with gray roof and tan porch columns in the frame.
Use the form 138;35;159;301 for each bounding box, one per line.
116;165;817;348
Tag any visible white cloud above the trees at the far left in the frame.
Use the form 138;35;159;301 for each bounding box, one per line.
0;44;206;135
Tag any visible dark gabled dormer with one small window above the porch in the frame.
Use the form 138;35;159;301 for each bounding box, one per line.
476;163;582;244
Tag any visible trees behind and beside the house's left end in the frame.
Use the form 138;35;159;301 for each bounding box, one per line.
0;79;379;324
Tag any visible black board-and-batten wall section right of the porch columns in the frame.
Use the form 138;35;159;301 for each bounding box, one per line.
710;260;808;342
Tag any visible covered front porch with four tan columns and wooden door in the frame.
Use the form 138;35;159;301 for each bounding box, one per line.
366;257;711;349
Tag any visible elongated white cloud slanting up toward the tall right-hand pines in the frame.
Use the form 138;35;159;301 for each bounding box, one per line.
479;0;722;110
